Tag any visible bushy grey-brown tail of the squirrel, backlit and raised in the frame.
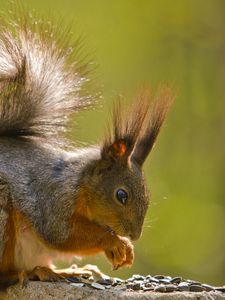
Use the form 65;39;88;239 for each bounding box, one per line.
0;13;92;136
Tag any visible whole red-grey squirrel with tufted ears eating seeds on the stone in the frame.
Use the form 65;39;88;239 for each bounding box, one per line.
0;12;173;284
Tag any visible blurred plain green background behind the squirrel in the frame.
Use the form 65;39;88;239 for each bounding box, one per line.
1;0;225;285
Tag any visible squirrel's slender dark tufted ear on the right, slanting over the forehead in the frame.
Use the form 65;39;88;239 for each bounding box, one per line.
132;86;174;166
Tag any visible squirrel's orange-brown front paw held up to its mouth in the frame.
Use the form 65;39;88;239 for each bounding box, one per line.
105;236;134;270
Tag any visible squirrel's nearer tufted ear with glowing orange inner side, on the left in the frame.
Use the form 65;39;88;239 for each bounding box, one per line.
102;92;149;160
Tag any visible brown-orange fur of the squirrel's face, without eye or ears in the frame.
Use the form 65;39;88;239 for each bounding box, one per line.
79;156;149;240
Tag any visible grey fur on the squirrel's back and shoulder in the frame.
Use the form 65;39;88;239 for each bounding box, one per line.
0;138;100;244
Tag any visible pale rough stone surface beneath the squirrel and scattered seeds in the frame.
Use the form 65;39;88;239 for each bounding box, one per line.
0;282;225;300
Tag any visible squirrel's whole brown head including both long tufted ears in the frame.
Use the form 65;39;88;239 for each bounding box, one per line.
78;88;172;240
